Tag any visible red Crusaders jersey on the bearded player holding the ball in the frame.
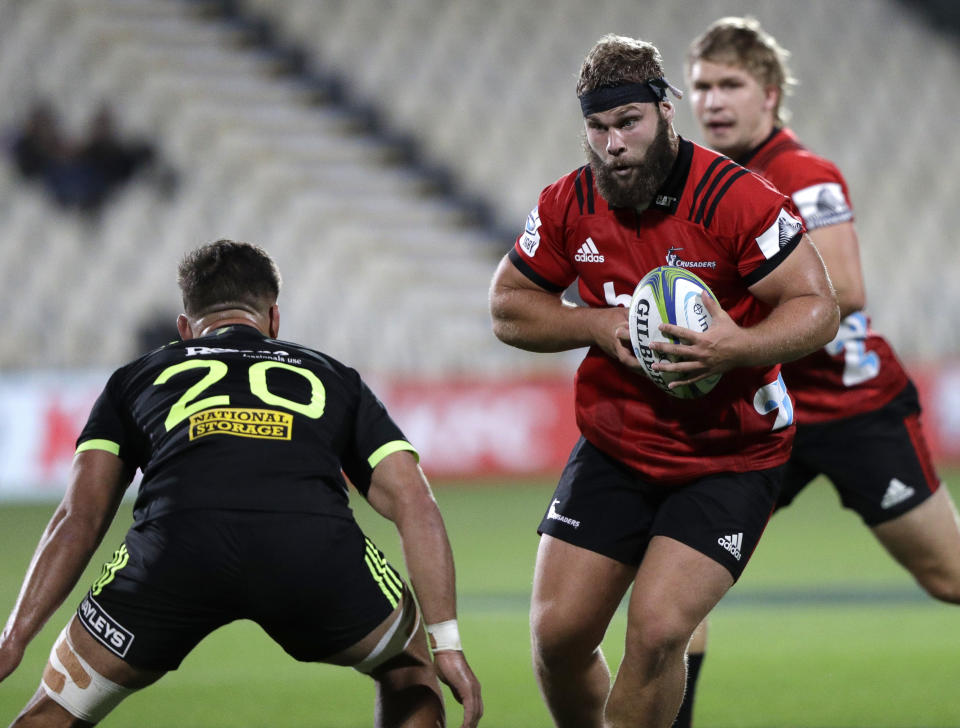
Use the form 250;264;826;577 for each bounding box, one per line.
510;139;803;484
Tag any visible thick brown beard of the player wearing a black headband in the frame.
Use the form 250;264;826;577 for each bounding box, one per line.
584;114;676;210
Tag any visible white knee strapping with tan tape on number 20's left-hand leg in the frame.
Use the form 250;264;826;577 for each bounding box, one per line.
41;627;135;723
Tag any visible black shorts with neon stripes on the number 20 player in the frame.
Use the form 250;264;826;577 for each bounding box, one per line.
77;510;405;670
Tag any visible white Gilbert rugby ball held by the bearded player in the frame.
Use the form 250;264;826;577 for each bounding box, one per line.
629;265;721;399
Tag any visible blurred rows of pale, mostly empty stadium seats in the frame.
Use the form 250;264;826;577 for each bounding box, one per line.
0;0;960;375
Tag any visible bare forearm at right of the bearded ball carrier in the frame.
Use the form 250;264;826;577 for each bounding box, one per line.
742;294;840;366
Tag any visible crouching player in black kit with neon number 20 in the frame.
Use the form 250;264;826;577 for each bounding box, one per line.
0;240;483;728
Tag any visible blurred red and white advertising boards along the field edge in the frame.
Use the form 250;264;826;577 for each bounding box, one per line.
0;360;960;500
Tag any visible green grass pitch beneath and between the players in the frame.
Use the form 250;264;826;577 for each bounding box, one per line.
0;472;960;728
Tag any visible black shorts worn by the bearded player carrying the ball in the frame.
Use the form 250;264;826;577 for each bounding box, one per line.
537;437;783;581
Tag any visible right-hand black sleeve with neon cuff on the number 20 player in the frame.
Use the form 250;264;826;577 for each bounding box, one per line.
341;375;419;496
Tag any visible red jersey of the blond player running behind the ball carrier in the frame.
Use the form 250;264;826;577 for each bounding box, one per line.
740;129;908;425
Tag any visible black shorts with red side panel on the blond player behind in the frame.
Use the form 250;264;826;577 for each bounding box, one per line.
777;382;940;526
